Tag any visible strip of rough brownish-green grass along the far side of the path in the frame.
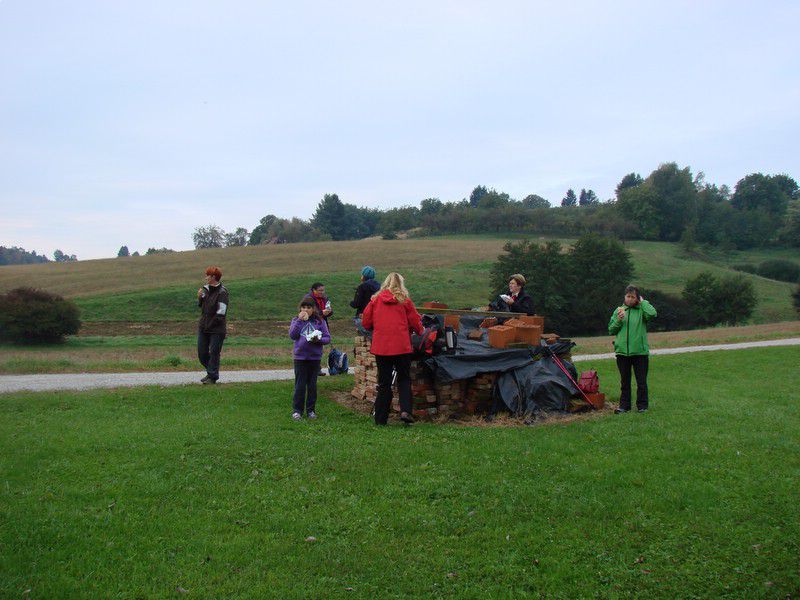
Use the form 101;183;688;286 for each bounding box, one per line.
0;321;800;374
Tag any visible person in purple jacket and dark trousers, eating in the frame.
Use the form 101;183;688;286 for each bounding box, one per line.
289;298;331;421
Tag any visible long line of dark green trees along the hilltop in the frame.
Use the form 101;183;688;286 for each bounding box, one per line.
193;162;800;250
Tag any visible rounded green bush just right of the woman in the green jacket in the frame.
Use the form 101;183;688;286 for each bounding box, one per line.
683;271;758;325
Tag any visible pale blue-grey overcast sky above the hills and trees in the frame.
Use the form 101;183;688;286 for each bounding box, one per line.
0;0;800;259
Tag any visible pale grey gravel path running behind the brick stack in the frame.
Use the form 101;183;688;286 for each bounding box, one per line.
0;338;800;394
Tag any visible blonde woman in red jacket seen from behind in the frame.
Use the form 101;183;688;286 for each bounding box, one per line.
362;273;422;425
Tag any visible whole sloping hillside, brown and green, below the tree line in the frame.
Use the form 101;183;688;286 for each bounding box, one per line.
0;236;800;323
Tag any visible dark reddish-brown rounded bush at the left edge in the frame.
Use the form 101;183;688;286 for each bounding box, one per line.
0;288;81;343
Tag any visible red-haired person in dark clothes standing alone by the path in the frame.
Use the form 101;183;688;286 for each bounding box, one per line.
197;267;228;384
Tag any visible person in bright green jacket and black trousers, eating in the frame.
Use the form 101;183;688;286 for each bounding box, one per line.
608;285;656;414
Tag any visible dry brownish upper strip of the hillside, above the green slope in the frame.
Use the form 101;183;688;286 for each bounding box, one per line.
0;238;504;298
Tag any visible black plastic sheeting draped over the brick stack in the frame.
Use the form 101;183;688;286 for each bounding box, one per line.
418;315;578;416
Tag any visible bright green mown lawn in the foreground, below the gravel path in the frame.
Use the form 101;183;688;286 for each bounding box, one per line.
0;348;800;598
